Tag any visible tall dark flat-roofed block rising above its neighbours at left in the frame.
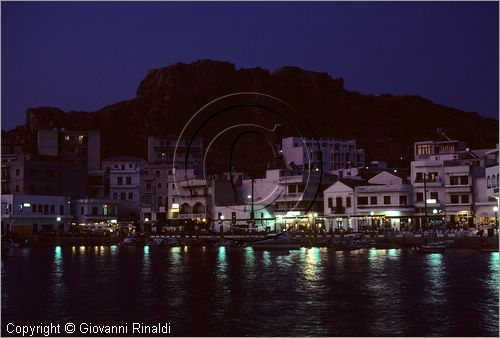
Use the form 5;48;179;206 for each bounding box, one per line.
38;129;101;170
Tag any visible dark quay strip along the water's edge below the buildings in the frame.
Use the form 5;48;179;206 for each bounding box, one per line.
8;230;499;251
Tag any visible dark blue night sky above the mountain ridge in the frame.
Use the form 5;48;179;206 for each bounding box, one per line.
1;2;499;129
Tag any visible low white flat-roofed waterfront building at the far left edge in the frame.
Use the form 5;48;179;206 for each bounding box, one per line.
1;194;72;237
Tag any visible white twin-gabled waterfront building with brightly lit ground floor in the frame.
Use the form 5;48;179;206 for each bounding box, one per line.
324;171;414;230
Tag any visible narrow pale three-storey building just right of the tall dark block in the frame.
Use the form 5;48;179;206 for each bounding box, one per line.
102;156;145;218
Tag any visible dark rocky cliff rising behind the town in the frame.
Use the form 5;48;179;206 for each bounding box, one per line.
2;60;498;173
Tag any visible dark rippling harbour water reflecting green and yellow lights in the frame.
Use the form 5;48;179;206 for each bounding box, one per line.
2;246;499;336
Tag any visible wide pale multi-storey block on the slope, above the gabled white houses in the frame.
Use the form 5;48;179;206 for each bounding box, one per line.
281;136;365;173
